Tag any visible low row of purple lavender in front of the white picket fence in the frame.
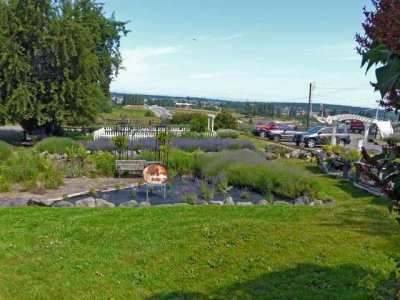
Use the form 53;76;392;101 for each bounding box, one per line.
85;138;255;152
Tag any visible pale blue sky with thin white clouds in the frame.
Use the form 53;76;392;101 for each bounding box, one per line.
104;0;379;108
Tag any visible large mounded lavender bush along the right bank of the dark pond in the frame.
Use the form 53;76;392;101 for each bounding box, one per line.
195;150;320;199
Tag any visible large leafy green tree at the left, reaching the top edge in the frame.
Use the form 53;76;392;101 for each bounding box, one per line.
0;0;127;135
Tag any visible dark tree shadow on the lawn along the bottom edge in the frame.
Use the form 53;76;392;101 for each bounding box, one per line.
148;264;396;300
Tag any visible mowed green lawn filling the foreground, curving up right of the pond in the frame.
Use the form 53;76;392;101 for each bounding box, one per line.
0;160;400;299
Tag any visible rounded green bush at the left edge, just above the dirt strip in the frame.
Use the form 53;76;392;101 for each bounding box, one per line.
0;149;63;189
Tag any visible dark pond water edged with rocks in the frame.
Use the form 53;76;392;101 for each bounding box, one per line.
69;178;265;206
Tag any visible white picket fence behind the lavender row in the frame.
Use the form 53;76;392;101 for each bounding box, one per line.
93;127;217;141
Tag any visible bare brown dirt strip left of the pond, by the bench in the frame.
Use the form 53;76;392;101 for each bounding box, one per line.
0;178;140;201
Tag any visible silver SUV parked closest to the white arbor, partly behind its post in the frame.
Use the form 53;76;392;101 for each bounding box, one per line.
293;126;350;148
